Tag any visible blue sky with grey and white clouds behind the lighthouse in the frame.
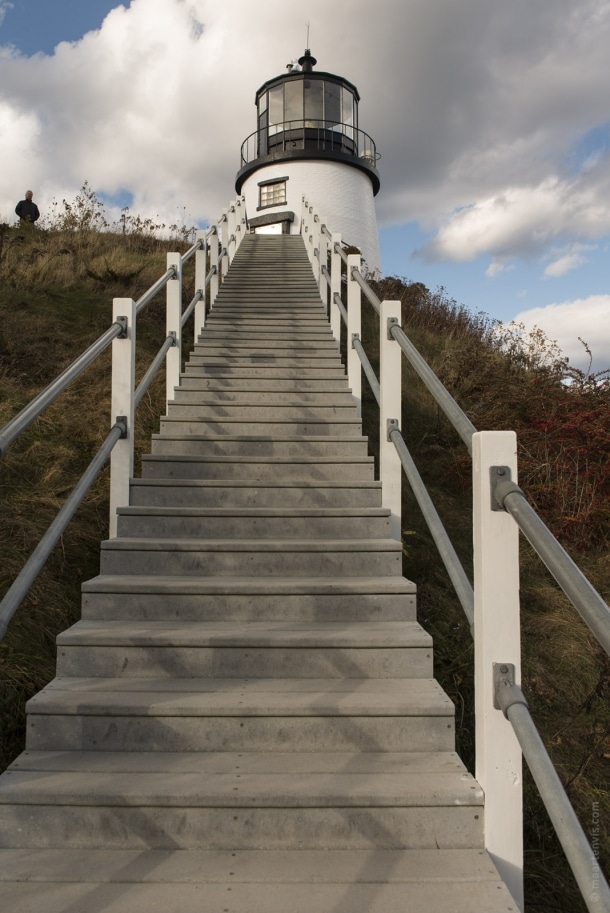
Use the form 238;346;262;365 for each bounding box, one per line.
0;0;610;371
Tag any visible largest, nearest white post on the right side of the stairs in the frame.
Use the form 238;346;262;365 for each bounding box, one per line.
472;431;523;909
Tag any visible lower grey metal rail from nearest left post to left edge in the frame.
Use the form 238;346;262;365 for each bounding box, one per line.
0;418;127;640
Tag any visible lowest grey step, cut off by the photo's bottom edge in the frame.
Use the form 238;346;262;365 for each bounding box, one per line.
0;848;515;913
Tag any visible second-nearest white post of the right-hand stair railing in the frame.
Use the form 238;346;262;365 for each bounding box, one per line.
379;301;402;540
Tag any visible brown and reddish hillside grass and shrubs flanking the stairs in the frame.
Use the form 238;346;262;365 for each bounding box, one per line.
0;185;610;913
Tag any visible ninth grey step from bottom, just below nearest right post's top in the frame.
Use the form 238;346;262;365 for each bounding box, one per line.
142;454;375;482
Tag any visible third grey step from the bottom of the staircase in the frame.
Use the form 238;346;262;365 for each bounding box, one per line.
21;677;454;756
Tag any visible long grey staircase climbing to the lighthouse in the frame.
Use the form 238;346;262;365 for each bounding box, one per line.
0;236;517;913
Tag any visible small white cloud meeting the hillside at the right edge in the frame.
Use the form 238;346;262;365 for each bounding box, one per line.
515;295;610;372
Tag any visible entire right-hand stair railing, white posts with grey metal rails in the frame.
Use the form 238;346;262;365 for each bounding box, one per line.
301;199;610;913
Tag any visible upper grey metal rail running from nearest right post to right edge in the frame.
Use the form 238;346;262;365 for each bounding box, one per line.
492;467;610;655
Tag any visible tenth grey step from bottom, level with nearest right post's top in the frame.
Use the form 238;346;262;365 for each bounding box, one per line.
152;432;368;460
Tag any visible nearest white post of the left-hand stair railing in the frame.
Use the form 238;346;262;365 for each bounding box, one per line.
108;298;136;539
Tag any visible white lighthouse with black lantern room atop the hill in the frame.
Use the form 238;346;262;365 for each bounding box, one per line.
235;49;380;274
